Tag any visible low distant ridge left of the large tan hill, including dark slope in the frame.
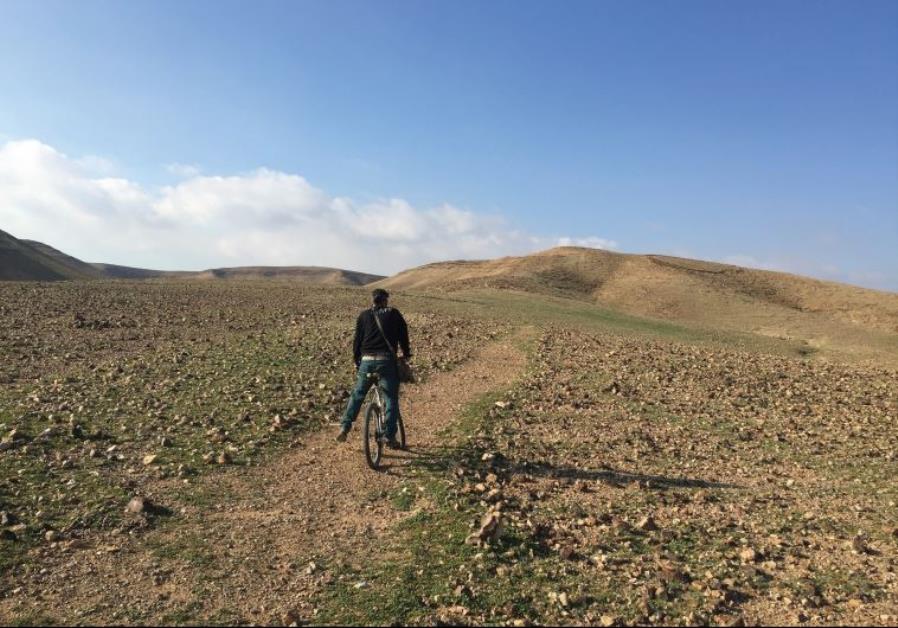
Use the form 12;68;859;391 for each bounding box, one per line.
0;231;384;286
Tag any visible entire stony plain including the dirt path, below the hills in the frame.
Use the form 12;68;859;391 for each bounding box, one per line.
0;284;898;625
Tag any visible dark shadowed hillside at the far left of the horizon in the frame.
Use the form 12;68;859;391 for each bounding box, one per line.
0;231;101;281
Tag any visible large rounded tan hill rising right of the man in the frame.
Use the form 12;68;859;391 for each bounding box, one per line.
375;247;898;360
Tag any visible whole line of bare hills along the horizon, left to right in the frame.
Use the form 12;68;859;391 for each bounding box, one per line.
7;231;898;346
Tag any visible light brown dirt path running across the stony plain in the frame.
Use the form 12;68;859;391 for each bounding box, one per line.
0;328;525;624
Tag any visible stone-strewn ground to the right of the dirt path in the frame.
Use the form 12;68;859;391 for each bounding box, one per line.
422;329;898;624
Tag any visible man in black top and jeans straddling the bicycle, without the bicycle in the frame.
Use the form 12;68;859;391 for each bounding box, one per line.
337;288;412;449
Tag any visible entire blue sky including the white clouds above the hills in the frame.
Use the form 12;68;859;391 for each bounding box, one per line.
0;0;898;290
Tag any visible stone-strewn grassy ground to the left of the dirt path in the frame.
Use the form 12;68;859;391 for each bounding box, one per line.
0;282;501;574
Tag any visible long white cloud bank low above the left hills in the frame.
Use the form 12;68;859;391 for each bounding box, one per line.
0;139;618;274
